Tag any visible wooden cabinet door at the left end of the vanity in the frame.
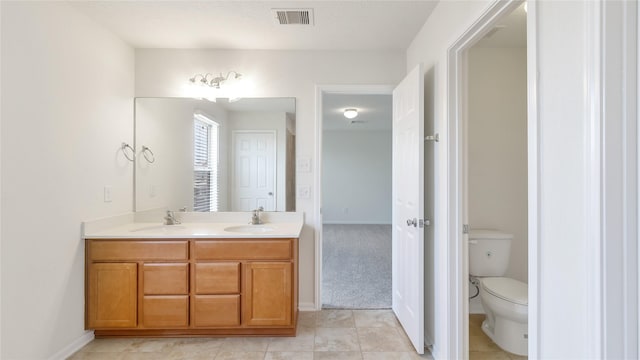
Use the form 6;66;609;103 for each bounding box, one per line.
87;263;138;329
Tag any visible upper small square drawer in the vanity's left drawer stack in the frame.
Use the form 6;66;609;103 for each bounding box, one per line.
142;264;189;295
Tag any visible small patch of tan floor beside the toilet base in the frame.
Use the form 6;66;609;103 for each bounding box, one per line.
469;314;527;360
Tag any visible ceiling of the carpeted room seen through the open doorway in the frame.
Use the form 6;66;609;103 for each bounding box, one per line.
322;93;392;131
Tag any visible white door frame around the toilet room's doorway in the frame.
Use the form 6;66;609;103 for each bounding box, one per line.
445;0;540;359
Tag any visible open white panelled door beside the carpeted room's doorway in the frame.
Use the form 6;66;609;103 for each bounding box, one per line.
392;65;424;354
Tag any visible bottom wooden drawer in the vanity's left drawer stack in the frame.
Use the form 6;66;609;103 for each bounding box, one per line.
142;295;189;327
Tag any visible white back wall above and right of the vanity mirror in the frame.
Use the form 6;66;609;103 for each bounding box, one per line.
136;49;405;308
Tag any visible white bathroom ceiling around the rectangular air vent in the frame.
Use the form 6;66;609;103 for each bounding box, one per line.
69;0;437;51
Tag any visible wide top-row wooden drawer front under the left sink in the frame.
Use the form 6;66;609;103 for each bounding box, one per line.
89;240;189;261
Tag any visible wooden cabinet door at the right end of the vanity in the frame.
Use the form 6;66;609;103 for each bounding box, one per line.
242;262;293;326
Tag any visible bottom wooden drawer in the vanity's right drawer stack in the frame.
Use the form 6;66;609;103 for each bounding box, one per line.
191;295;240;327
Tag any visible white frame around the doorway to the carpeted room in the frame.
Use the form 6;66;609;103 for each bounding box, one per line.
313;85;395;310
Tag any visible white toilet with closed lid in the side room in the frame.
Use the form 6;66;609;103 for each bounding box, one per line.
469;230;528;355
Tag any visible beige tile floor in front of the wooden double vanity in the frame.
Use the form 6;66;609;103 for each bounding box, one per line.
69;310;432;360
